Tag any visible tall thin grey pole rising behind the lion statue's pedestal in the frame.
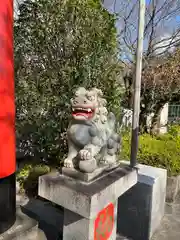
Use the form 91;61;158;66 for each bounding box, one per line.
130;0;146;167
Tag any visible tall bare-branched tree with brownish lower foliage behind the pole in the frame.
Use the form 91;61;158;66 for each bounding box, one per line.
105;0;180;130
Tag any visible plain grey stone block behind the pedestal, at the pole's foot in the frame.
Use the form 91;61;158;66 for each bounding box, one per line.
117;161;167;240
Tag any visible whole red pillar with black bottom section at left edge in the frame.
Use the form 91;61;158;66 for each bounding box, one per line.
0;0;16;234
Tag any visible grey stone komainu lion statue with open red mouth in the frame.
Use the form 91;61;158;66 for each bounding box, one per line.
64;87;121;173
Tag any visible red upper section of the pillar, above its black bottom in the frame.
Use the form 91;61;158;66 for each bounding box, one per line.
0;0;16;178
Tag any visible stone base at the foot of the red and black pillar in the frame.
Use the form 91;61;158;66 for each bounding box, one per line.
0;207;38;240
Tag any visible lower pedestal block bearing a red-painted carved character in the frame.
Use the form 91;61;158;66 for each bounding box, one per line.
63;202;117;240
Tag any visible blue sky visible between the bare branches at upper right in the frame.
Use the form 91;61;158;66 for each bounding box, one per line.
105;0;180;58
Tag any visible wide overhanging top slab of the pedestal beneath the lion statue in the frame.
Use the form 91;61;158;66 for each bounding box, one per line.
39;165;137;219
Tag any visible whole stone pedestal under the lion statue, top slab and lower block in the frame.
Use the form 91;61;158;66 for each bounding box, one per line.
39;165;137;240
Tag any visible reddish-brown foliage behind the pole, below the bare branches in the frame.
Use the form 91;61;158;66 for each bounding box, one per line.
125;48;180;132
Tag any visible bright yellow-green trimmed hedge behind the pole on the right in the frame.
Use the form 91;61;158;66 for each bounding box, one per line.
121;126;180;176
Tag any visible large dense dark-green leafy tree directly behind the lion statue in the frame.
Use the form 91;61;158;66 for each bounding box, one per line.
14;0;122;163
